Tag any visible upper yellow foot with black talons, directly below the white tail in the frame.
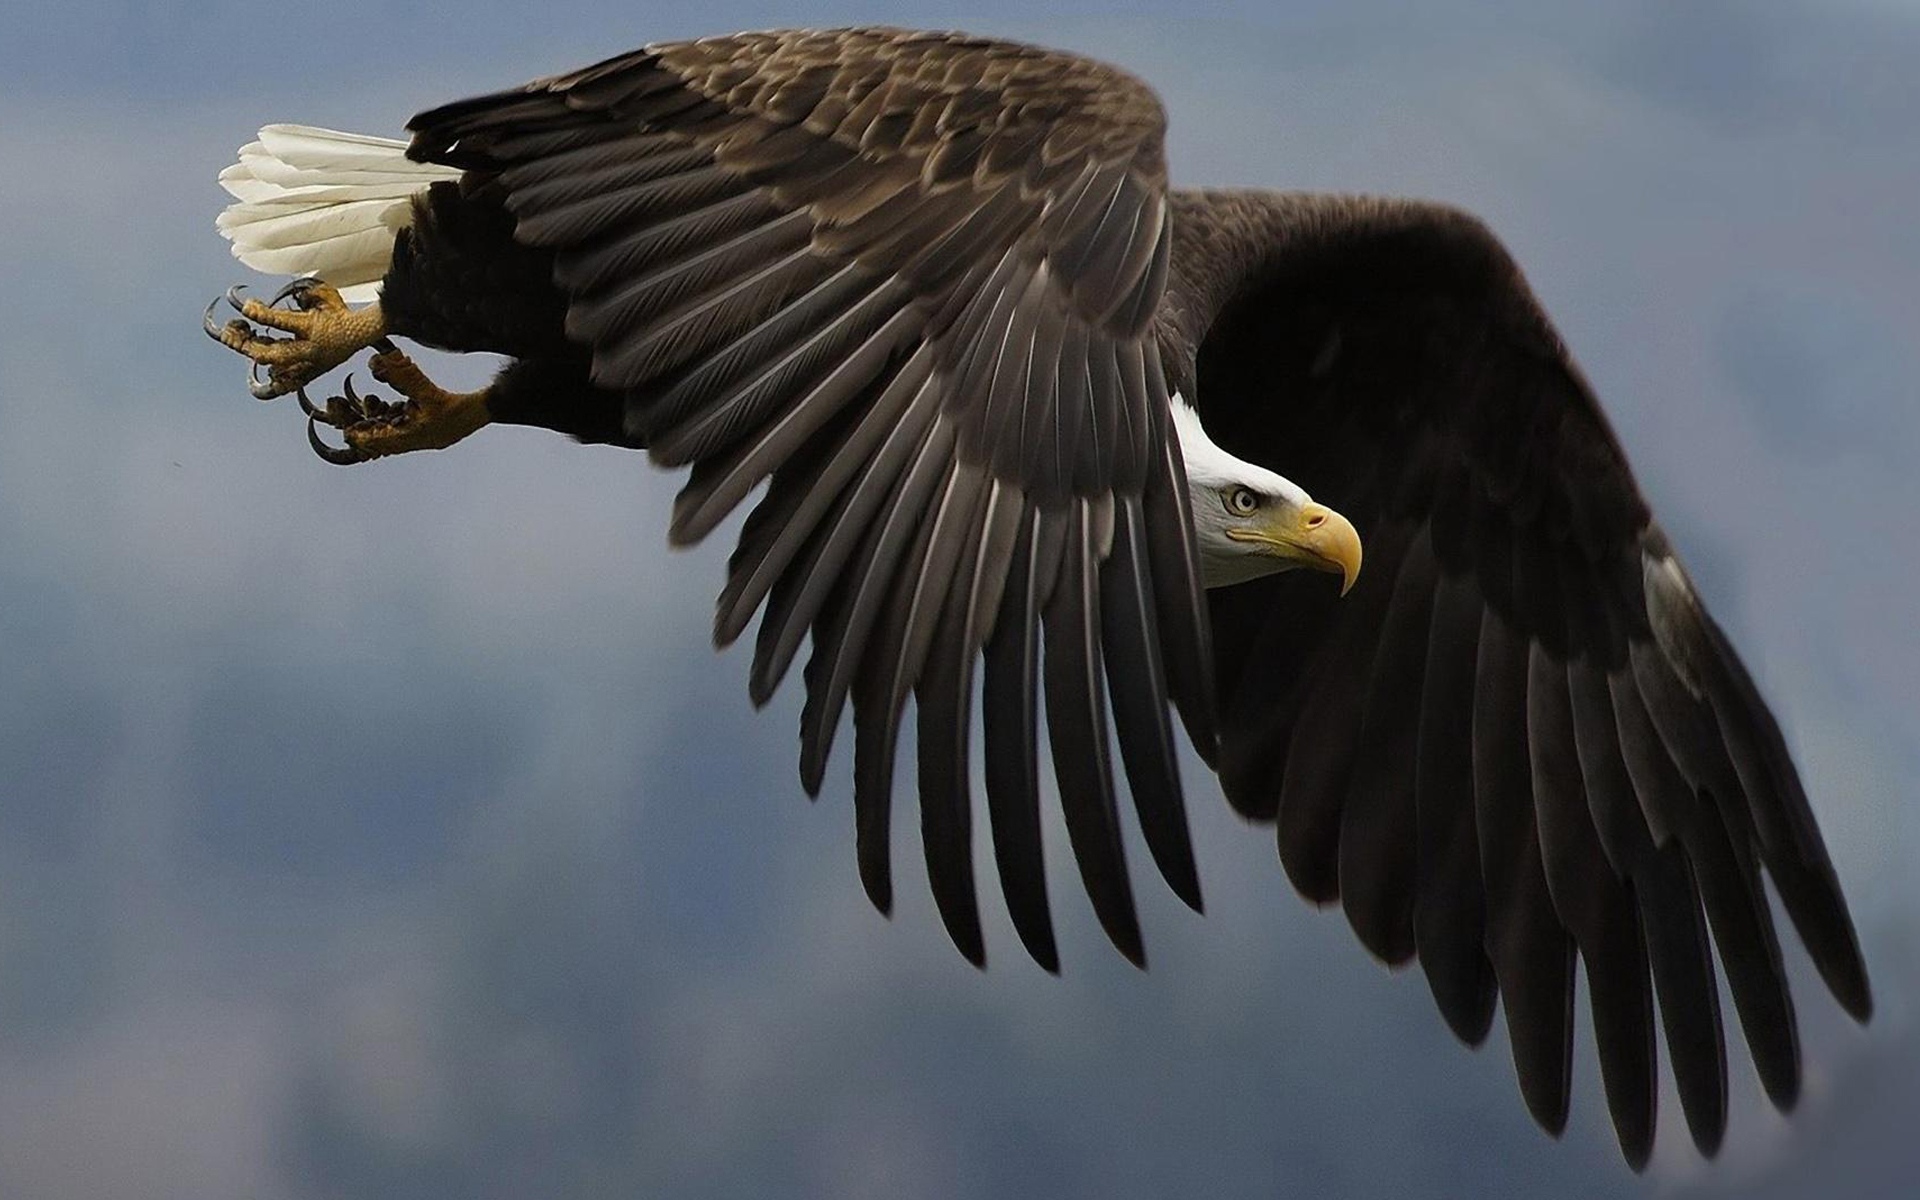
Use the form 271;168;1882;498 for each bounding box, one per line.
202;278;392;399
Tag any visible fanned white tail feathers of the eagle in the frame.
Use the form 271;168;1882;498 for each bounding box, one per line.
213;125;461;303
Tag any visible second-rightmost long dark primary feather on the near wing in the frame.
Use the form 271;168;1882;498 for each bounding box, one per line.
1100;497;1206;912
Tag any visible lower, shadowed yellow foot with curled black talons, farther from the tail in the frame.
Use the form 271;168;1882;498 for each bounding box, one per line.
294;349;493;467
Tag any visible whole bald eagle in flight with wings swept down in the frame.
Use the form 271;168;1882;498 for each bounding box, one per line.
205;29;1872;1169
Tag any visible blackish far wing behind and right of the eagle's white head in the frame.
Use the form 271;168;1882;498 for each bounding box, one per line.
1181;196;1870;1165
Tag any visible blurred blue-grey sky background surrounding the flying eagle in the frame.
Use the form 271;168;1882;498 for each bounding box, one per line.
0;0;1920;1200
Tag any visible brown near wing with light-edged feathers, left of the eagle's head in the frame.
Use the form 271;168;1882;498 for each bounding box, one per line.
411;29;1213;970
